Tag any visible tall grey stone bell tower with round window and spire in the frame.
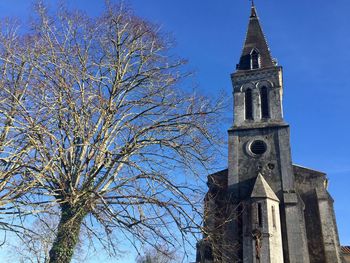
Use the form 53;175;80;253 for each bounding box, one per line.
226;4;310;263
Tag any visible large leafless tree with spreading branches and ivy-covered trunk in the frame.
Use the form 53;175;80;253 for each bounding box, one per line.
2;1;222;263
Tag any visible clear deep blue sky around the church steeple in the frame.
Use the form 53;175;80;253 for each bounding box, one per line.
0;0;350;262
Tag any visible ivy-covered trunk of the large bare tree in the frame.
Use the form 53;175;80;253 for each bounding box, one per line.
49;204;86;263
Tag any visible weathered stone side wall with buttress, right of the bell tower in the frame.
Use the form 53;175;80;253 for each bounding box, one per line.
293;166;341;263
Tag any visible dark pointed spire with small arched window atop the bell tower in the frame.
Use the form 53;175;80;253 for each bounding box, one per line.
237;4;275;70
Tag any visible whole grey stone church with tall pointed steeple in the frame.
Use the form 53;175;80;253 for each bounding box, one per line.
196;5;342;263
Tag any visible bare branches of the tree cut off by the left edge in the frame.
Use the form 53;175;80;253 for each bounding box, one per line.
0;18;34;233
